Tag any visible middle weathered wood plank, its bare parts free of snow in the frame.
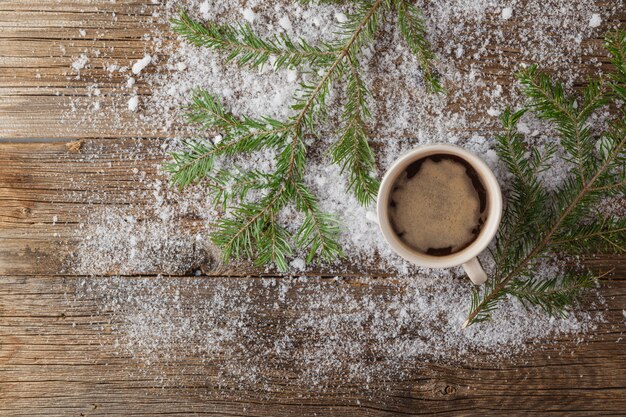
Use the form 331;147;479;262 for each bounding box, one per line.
0;139;626;275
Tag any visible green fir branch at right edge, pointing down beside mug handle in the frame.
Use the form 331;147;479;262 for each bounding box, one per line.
464;34;626;327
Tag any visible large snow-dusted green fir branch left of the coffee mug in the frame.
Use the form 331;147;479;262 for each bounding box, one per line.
165;0;443;271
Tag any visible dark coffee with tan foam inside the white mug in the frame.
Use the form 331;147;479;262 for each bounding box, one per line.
389;154;486;256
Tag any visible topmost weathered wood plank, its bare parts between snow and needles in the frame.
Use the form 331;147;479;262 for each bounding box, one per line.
0;1;626;138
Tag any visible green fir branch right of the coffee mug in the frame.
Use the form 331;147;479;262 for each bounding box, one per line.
464;31;626;327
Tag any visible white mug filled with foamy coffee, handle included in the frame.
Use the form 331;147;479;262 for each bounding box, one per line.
377;144;502;285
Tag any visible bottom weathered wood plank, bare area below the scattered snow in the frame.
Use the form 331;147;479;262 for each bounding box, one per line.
0;276;626;417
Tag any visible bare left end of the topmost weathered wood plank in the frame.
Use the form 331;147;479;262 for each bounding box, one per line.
0;1;167;138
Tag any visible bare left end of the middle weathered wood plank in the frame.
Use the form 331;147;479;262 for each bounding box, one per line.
0;140;158;274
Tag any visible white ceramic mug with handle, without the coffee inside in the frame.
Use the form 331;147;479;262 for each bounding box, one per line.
377;144;502;285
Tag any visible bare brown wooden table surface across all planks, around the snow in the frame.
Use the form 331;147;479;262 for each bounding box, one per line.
0;0;626;416
